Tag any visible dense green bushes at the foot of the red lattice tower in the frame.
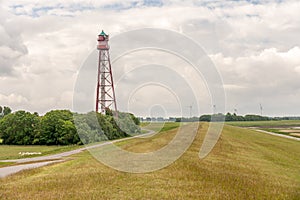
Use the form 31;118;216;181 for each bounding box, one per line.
0;106;141;145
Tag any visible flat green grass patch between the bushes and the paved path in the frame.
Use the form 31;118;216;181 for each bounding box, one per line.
0;145;83;160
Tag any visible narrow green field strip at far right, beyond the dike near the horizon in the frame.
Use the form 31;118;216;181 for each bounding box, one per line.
226;120;300;127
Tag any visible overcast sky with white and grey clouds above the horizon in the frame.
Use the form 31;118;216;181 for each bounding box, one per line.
0;0;300;116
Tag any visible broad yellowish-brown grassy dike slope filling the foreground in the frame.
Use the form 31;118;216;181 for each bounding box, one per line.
0;123;300;200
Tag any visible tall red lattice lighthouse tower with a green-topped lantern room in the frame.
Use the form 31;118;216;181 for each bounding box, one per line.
96;30;117;114
